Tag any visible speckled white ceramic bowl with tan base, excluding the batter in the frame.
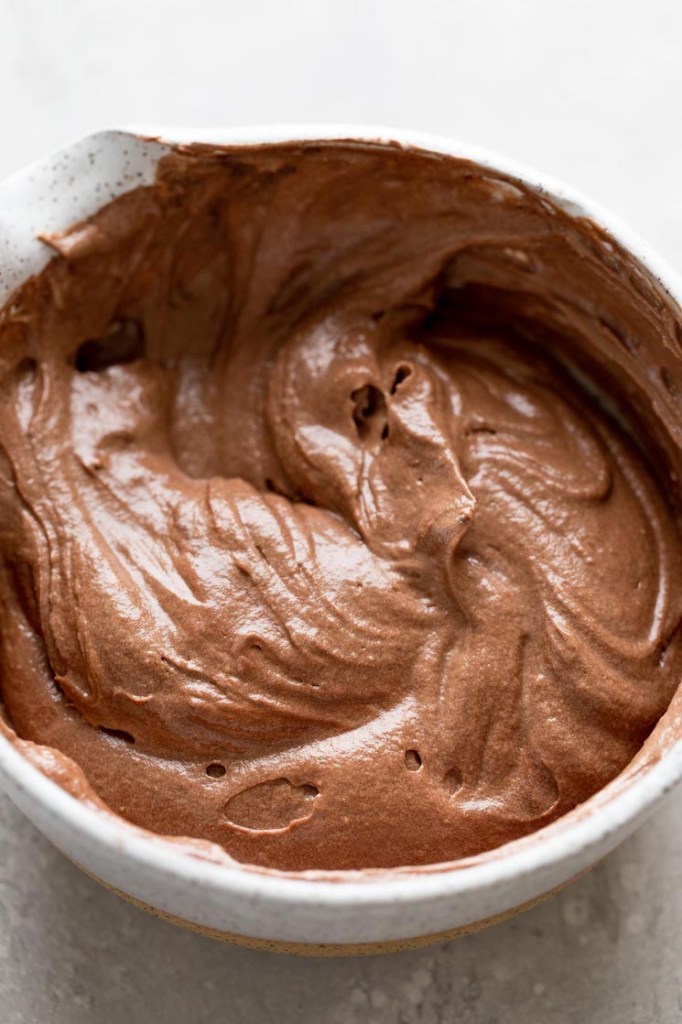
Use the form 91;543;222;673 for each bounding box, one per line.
0;125;682;953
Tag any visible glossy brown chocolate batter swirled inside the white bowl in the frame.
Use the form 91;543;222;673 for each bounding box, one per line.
0;143;682;869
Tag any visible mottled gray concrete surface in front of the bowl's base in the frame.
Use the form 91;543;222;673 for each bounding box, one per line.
0;794;682;1024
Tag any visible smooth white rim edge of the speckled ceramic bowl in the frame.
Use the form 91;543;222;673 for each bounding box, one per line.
0;124;682;908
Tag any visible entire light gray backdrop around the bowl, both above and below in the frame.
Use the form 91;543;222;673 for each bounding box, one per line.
0;0;682;1024
